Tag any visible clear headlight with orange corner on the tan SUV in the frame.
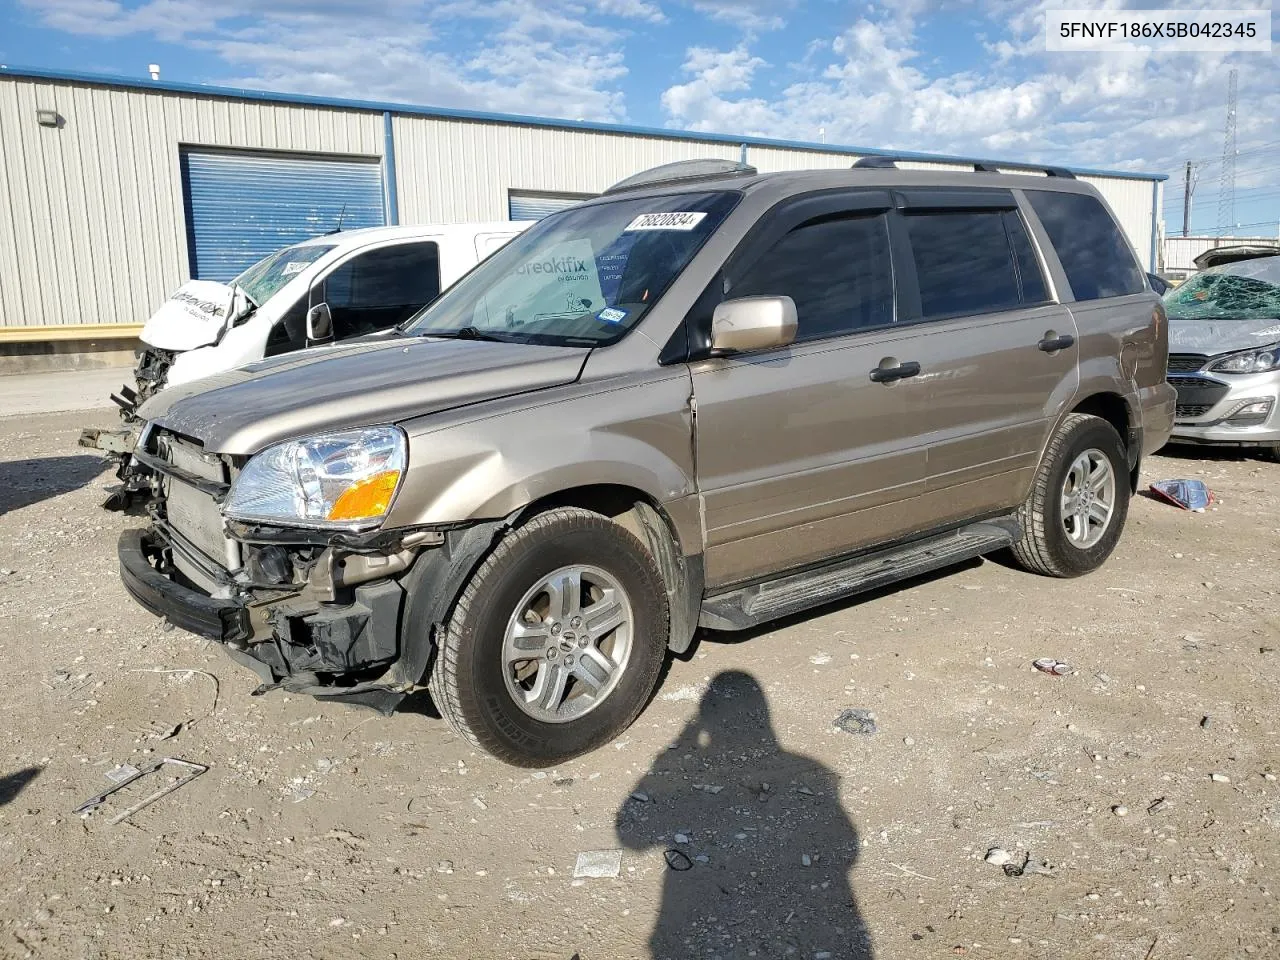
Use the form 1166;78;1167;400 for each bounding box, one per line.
223;426;408;527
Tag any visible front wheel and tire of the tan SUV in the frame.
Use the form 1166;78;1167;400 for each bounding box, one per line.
429;508;669;767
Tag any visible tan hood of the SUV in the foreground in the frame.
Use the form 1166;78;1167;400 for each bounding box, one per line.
138;337;590;454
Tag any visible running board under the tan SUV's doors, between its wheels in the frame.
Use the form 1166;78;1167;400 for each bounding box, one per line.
698;517;1021;630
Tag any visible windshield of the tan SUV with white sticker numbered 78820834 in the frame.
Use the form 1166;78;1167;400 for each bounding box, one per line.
404;192;740;346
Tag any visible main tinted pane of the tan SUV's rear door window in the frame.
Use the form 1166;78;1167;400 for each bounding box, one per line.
906;210;1021;319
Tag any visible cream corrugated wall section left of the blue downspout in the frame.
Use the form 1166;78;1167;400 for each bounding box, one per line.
0;78;383;326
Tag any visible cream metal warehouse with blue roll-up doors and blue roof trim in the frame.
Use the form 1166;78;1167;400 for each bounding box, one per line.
0;67;1165;371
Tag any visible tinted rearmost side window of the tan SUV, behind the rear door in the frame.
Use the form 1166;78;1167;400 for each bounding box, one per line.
1027;189;1146;300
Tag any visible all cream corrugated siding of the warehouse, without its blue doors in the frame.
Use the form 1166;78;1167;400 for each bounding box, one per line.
0;77;1158;326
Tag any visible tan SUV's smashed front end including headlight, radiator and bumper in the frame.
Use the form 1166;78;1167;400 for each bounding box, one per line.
118;426;502;712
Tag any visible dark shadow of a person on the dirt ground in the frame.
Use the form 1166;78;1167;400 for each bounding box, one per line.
616;671;872;960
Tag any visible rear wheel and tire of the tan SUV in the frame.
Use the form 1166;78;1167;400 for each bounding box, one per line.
1010;413;1129;577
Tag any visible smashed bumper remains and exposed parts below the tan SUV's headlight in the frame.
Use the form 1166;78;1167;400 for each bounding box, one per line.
118;521;504;713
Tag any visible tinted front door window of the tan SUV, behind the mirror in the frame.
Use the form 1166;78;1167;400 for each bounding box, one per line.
730;215;893;340
